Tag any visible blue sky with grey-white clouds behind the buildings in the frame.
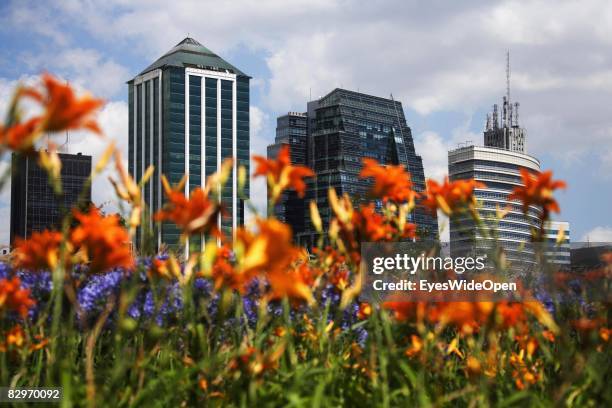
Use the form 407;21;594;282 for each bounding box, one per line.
0;0;612;244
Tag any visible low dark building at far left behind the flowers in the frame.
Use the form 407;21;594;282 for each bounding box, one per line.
10;153;91;245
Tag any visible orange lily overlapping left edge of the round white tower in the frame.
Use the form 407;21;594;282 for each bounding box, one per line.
422;177;486;216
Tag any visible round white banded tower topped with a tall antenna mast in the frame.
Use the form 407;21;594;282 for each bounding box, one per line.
448;57;542;269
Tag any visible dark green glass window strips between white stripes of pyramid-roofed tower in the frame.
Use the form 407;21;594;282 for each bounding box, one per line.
130;68;249;244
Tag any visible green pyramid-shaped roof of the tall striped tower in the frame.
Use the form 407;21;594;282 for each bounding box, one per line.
138;37;248;77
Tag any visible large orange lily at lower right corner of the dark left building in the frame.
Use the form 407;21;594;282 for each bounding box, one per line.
70;207;134;273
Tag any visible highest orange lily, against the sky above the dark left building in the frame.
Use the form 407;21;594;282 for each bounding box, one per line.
22;74;104;133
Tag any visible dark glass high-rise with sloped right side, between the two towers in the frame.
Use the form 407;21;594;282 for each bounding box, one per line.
269;88;438;245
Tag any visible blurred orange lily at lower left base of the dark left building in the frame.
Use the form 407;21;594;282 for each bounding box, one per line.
13;230;62;271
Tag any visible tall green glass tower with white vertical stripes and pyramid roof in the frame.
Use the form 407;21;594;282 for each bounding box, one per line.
128;37;250;246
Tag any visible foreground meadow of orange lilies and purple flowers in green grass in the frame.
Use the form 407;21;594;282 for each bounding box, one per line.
0;74;612;407
